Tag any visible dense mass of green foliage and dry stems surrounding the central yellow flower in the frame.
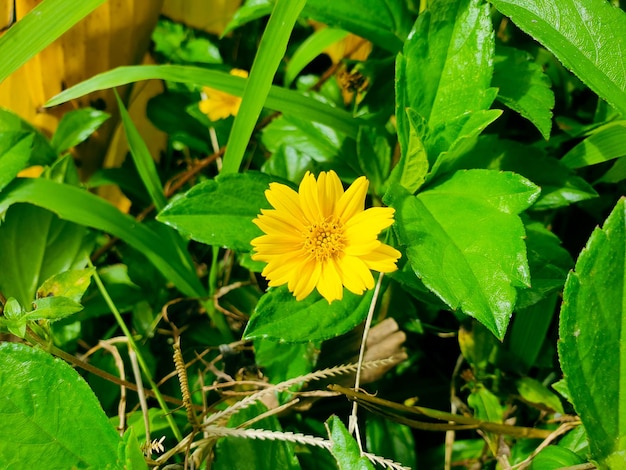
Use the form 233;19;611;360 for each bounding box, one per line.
0;0;626;470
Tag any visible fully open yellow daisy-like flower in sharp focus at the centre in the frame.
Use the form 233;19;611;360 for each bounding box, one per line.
251;171;401;303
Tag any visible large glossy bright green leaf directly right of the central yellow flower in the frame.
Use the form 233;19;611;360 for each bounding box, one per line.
385;170;539;339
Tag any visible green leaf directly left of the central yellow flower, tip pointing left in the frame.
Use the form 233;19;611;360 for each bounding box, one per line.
157;172;272;251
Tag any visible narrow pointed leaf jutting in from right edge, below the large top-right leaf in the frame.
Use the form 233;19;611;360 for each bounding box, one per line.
561;121;626;168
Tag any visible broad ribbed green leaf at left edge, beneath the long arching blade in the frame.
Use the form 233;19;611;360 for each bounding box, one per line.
0;204;91;308
